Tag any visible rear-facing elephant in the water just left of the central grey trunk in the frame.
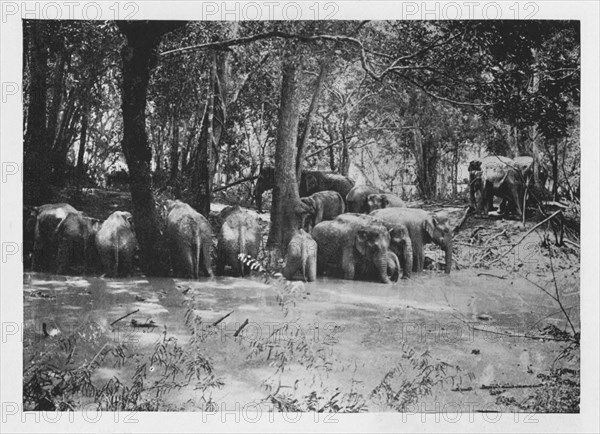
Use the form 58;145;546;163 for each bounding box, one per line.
217;206;262;276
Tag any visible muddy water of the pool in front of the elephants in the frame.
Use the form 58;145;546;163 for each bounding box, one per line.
24;271;579;411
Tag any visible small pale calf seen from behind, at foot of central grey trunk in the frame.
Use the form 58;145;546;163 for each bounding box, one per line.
283;229;317;282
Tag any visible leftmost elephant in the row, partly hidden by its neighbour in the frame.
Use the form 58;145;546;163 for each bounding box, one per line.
31;203;78;272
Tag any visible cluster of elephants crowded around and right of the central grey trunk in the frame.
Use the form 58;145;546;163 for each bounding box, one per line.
256;167;452;283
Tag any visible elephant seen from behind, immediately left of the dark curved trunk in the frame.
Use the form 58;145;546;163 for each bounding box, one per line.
95;211;138;277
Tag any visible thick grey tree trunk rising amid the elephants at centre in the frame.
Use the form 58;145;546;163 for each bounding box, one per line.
267;45;302;265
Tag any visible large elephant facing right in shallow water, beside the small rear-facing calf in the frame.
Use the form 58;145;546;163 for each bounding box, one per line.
312;213;391;283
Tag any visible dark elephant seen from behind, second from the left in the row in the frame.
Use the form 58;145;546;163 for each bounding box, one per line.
55;212;100;274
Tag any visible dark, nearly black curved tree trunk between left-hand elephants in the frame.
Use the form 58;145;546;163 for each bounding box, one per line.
117;21;185;275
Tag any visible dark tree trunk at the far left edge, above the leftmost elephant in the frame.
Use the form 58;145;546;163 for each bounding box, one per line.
23;20;51;205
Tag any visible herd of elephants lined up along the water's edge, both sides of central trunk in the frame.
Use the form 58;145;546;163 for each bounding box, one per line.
23;167;452;283
